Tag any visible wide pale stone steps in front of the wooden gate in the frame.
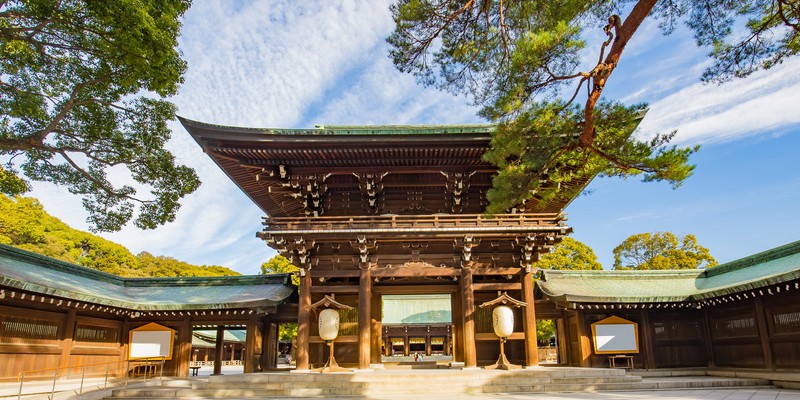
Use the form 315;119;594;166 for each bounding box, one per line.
103;367;769;400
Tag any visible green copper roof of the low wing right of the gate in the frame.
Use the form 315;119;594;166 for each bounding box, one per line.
537;241;800;303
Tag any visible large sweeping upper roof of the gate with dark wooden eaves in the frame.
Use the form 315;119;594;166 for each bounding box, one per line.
179;118;589;217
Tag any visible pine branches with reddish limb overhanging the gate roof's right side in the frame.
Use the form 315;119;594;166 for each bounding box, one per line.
387;0;800;213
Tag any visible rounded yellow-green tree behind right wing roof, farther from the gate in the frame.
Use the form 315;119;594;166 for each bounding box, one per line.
614;232;717;270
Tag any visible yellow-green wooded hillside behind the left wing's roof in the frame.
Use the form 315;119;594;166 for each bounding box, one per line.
0;194;239;277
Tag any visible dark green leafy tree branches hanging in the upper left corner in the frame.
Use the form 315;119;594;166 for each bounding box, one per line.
0;0;200;231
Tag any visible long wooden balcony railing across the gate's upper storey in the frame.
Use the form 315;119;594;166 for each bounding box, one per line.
263;213;564;232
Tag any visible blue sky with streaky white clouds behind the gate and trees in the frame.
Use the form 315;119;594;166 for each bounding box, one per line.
31;0;800;274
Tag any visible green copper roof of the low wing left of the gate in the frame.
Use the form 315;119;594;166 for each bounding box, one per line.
0;245;295;311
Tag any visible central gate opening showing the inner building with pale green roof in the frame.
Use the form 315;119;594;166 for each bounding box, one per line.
381;294;453;362
